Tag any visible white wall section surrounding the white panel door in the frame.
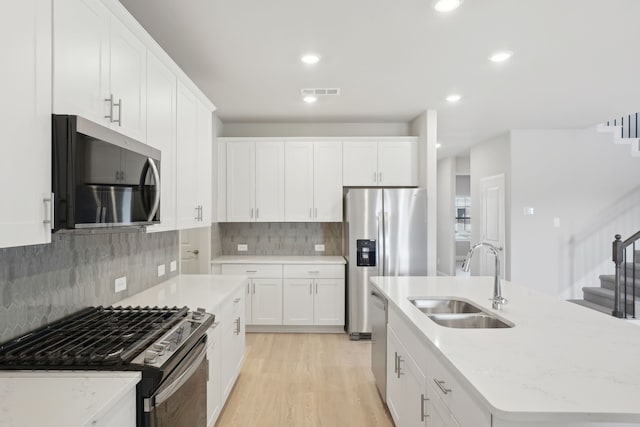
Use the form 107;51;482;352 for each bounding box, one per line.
469;133;511;279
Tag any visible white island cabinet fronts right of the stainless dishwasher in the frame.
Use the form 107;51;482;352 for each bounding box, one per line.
387;306;491;427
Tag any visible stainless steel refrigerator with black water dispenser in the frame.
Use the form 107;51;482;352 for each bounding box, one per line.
343;188;427;340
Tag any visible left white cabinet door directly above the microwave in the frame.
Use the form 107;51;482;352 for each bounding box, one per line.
52;0;111;125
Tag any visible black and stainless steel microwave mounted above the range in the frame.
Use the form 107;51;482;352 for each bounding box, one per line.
51;114;160;231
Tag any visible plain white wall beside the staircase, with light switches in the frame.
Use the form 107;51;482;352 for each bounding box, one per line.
512;130;640;298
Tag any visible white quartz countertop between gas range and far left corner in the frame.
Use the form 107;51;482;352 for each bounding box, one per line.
114;274;247;314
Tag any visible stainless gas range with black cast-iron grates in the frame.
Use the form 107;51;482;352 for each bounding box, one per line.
0;307;215;426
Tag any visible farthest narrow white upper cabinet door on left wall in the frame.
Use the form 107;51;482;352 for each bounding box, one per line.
196;101;213;226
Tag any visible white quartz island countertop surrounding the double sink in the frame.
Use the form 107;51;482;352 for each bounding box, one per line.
372;277;640;422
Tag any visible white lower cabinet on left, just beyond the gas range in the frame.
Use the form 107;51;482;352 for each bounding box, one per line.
207;287;245;427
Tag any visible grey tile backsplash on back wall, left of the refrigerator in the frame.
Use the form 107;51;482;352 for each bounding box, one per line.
219;222;342;256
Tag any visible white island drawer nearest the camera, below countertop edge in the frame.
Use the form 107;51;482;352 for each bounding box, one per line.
427;354;491;427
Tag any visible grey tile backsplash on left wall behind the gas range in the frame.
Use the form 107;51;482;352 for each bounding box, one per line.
0;231;179;342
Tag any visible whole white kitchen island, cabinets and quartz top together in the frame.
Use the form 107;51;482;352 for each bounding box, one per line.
372;277;640;427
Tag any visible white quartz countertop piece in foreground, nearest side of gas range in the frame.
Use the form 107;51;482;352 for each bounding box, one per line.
0;371;141;427
